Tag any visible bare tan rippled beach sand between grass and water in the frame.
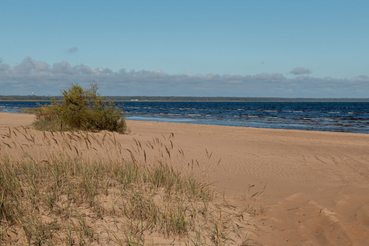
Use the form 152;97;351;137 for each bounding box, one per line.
0;113;369;245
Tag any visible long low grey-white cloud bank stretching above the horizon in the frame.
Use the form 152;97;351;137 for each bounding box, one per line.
0;57;369;98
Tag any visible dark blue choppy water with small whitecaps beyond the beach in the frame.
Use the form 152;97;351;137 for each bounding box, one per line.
0;102;369;133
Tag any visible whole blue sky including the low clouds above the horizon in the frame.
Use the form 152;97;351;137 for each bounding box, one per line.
0;0;369;98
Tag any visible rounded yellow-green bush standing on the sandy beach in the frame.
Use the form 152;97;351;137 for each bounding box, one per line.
34;84;126;133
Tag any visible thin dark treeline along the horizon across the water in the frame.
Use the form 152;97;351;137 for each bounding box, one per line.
0;95;369;102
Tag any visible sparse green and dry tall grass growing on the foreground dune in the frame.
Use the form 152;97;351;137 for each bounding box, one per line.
0;128;254;245
